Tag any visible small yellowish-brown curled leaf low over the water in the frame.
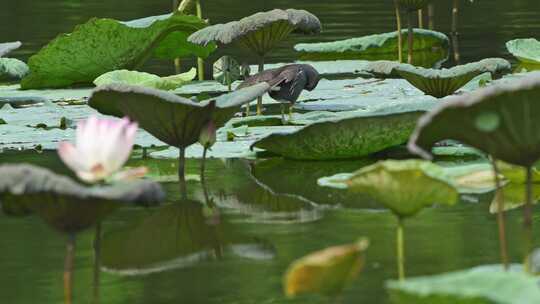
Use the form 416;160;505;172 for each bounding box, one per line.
284;239;368;297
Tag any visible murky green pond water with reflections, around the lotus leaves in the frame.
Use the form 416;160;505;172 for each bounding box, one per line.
0;0;540;304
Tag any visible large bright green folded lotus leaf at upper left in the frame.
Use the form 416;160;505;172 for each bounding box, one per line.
21;13;214;89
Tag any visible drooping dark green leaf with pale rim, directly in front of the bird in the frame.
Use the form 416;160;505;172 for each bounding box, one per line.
88;83;269;148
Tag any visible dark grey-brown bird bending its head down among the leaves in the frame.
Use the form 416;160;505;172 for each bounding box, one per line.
237;64;320;104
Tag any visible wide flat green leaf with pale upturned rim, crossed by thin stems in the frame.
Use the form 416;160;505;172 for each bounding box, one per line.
294;29;449;60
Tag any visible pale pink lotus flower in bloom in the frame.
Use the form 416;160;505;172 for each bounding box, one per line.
58;116;137;182
